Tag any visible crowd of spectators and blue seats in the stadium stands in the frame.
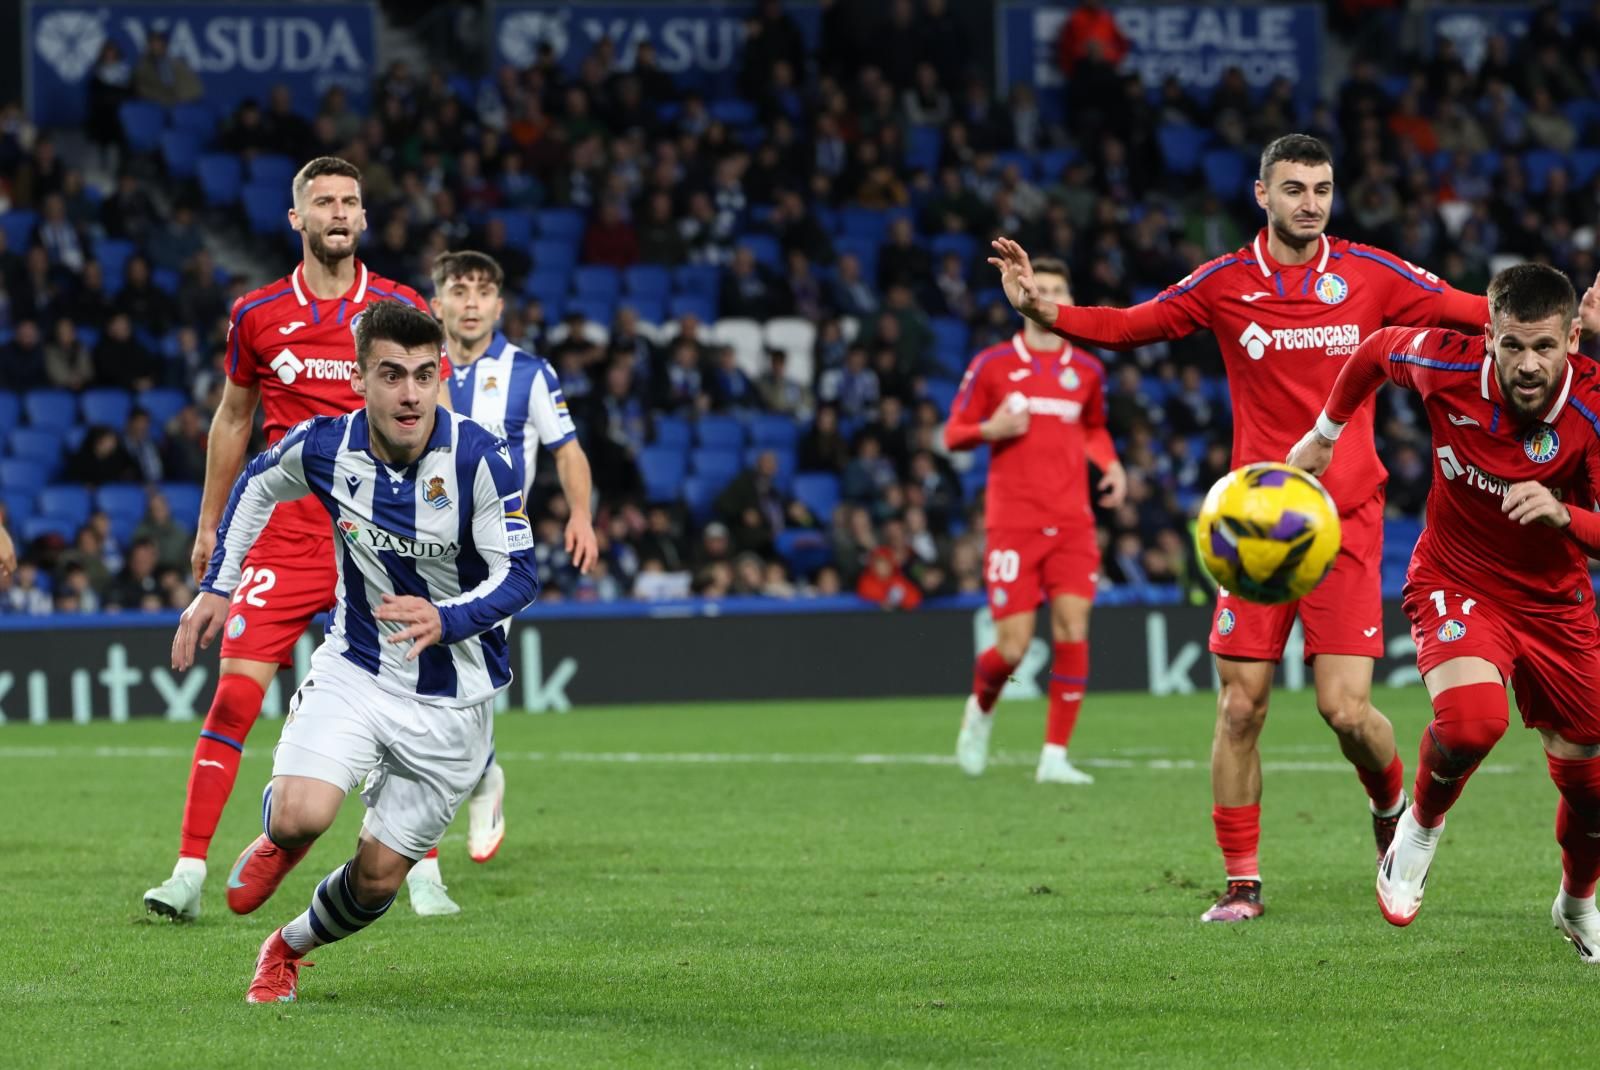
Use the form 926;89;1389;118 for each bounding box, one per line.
0;0;1600;613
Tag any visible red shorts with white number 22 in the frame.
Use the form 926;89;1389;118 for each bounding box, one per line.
222;525;339;667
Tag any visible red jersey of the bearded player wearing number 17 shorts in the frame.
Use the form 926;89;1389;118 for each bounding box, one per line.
1328;328;1600;608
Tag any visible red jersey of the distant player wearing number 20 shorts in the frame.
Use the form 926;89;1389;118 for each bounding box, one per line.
947;334;1109;528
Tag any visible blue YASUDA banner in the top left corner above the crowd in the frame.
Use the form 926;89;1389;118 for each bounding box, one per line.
24;3;378;126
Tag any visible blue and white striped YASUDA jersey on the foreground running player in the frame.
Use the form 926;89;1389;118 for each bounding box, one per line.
202;408;539;705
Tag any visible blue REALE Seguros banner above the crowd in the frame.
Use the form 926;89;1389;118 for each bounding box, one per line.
995;0;1323;120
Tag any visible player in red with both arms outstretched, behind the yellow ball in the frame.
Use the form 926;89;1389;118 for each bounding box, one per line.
990;134;1486;921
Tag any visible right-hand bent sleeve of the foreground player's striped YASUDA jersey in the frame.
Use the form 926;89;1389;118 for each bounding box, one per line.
438;440;539;643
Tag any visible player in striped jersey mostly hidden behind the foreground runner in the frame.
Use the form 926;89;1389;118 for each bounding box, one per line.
406;251;598;904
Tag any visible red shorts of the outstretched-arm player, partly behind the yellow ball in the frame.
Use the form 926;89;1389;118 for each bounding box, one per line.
1211;491;1384;661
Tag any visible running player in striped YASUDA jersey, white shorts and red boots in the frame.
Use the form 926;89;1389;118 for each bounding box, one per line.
173;295;538;1003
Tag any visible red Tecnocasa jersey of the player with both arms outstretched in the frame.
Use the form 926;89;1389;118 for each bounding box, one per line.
1056;230;1488;512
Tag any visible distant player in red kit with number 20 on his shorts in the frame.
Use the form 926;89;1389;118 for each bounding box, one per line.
944;259;1128;784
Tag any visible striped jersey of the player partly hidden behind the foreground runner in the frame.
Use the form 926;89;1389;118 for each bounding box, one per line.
450;331;578;496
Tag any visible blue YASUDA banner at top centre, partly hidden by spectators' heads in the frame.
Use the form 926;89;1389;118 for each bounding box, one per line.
494;0;822;98
